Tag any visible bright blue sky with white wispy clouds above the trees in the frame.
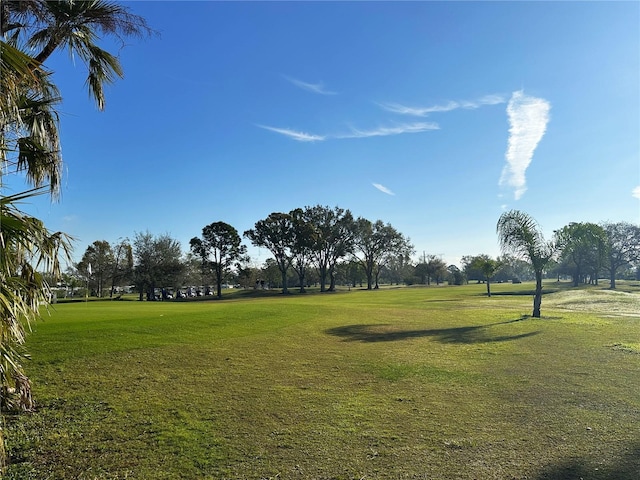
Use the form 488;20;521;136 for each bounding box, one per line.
15;1;640;263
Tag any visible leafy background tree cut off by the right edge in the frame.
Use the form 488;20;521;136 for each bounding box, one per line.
602;222;640;289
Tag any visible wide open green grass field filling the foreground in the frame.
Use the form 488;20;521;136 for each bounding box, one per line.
6;283;640;479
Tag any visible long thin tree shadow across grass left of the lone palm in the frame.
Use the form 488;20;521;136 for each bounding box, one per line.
325;318;540;344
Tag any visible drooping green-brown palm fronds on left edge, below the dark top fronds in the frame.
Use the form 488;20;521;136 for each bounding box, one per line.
0;41;70;473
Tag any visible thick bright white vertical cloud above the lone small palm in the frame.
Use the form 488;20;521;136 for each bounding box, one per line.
499;91;551;200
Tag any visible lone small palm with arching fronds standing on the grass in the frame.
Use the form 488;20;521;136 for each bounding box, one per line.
496;210;556;318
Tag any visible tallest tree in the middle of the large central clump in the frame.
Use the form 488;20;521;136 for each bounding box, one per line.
305;205;354;292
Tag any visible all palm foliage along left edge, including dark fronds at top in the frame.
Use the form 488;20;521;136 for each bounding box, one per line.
0;0;150;464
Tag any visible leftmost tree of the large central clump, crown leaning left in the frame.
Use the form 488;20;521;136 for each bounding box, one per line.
244;212;295;293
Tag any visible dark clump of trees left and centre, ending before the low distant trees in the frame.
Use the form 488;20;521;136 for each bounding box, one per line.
63;205;413;300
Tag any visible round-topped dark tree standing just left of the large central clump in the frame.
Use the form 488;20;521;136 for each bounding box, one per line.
189;222;247;298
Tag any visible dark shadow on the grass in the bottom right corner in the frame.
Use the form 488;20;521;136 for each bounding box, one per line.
534;442;640;480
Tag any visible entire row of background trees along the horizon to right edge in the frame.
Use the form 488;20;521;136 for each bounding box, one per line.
63;214;640;300
